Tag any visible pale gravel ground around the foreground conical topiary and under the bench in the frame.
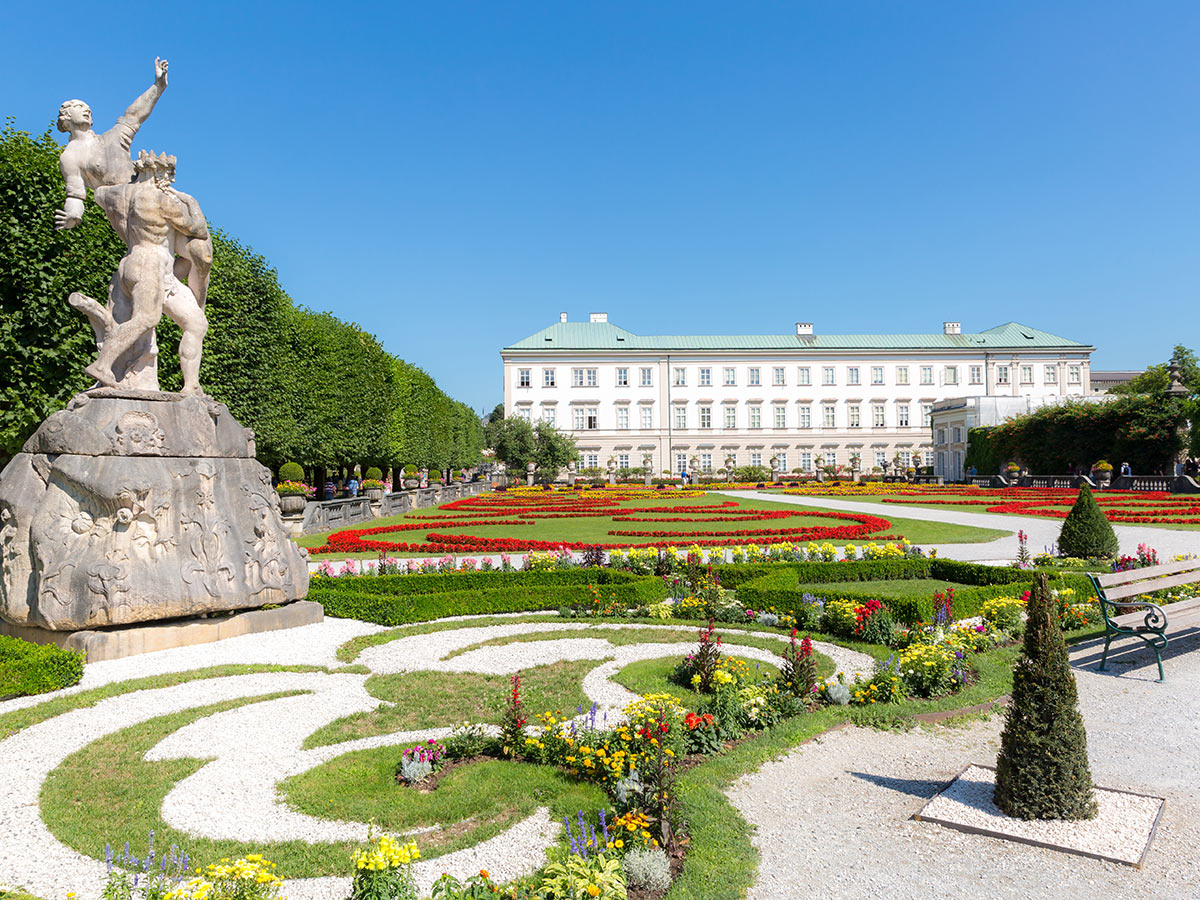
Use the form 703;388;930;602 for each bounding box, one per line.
730;636;1200;900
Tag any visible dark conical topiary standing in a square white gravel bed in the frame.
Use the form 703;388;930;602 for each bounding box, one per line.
992;575;1096;820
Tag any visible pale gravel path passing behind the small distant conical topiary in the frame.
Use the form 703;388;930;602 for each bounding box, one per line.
725;491;1200;562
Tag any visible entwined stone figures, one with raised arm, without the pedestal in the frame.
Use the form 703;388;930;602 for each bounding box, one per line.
54;59;212;392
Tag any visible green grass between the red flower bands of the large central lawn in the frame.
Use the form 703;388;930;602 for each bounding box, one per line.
296;492;1010;563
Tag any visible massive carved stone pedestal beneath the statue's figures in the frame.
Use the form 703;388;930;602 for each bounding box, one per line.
0;389;308;631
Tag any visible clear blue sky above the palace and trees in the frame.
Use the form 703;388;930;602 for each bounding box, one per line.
0;0;1200;408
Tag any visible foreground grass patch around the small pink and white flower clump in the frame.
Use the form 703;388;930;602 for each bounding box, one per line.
278;746;607;858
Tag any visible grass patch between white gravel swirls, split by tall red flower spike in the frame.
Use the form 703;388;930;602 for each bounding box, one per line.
304;662;600;753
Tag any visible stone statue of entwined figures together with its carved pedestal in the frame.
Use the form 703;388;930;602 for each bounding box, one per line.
0;60;308;634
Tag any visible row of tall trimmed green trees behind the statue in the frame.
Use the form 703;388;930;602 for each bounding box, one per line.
0;124;484;468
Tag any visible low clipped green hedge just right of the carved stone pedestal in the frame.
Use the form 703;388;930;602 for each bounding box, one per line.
308;569;667;625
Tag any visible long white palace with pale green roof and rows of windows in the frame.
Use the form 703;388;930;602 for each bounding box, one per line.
500;312;1096;475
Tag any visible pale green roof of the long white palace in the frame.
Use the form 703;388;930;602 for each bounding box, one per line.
504;322;1096;350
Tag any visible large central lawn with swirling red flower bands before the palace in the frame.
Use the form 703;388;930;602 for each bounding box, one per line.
296;492;1010;559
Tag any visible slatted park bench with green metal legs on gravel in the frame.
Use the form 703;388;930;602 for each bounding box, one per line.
1087;559;1200;682
